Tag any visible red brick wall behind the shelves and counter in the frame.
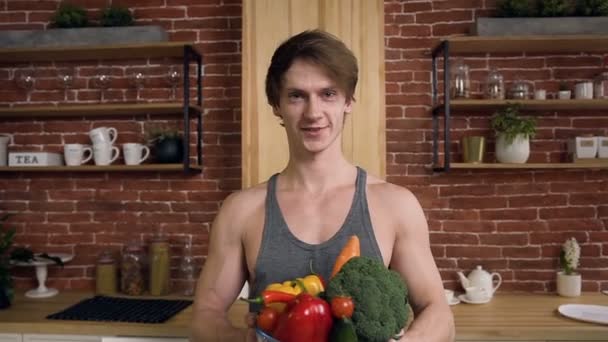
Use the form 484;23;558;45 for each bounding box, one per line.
0;0;608;291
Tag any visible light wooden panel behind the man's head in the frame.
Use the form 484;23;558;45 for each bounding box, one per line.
242;0;386;187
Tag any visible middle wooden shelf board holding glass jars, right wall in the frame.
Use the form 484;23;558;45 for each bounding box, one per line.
434;99;608;112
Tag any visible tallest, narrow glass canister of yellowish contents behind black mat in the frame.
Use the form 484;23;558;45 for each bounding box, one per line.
148;234;171;296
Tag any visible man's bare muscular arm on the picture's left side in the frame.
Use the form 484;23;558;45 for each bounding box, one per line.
191;195;254;342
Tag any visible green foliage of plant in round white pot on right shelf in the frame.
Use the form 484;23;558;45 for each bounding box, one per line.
491;104;536;145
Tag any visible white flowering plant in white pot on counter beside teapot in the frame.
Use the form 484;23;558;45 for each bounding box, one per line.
557;238;581;297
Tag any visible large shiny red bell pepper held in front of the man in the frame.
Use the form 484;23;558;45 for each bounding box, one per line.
272;293;333;342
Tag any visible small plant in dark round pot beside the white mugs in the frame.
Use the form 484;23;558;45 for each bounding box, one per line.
148;128;184;164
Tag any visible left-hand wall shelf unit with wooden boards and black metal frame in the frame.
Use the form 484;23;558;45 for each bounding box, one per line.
0;42;203;173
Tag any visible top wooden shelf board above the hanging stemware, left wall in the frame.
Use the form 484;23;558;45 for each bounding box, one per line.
0;42;202;62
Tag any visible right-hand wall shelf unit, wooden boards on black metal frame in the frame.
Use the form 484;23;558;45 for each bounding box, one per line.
431;35;608;172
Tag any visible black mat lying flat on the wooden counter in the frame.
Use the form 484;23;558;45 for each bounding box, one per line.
46;296;192;323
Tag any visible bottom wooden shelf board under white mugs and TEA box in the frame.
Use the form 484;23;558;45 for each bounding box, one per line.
0;164;202;172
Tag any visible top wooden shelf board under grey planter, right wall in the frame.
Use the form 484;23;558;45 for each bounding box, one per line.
433;35;608;54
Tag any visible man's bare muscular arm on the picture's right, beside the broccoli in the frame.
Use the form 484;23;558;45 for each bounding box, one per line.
391;189;455;342
